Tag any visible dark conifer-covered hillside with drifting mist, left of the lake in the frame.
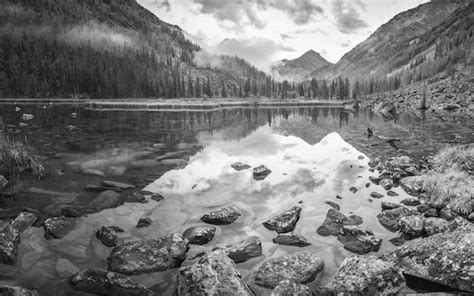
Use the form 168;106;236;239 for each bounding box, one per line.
0;0;269;98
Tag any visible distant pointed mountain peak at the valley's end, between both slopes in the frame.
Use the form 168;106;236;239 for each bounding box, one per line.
272;50;332;81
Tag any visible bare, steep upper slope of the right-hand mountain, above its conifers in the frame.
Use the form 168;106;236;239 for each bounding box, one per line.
308;0;466;79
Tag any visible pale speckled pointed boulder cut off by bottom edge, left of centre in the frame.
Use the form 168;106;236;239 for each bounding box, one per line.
177;250;254;296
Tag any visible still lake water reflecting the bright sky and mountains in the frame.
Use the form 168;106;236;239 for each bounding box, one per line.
0;104;474;295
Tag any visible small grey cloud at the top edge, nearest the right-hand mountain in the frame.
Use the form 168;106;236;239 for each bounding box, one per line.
332;0;369;34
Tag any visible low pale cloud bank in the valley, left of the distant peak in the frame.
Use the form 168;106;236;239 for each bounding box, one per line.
215;38;294;71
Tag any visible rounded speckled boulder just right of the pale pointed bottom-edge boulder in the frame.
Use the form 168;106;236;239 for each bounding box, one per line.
255;252;324;288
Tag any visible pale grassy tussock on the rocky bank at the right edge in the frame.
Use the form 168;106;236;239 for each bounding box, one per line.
422;144;474;215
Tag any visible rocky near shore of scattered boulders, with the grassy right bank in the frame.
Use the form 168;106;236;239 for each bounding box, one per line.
0;141;474;295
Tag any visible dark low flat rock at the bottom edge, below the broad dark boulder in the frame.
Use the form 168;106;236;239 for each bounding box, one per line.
69;268;154;296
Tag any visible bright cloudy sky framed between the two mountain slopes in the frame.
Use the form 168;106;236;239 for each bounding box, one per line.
138;0;428;70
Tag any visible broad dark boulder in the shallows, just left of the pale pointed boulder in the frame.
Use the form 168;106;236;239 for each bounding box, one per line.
107;234;189;275
